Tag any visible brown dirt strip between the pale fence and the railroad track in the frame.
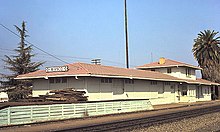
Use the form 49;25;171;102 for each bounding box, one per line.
0;101;220;132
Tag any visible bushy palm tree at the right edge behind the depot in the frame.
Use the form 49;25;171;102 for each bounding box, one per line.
192;30;220;82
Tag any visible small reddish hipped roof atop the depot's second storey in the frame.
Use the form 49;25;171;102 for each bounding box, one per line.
136;59;201;70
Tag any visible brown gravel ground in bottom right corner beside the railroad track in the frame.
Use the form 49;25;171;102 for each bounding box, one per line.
131;112;220;132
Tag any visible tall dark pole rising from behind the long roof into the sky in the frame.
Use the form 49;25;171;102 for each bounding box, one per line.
124;0;129;68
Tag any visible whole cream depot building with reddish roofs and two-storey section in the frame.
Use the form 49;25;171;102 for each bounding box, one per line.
15;58;220;104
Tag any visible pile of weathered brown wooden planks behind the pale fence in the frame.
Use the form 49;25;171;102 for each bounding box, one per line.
19;88;88;102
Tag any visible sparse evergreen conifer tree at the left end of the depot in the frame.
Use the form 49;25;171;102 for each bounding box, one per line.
3;21;44;100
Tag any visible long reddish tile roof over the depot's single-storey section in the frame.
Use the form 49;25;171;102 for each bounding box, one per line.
16;63;218;85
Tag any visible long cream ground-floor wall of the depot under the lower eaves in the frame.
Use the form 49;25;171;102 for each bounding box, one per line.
33;77;211;104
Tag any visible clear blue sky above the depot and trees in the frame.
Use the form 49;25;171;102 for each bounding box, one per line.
0;0;220;73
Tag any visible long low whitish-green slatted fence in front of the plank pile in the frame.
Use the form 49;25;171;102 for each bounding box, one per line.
0;100;153;126
